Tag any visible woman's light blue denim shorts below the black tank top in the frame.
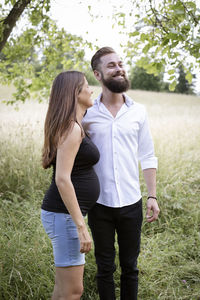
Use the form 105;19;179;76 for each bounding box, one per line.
41;209;85;267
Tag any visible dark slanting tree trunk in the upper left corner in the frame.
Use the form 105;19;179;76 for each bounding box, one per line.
0;0;31;52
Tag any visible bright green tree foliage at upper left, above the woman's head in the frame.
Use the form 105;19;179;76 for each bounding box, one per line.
0;0;94;104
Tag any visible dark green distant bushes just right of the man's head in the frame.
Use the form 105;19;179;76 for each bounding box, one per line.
130;66;168;91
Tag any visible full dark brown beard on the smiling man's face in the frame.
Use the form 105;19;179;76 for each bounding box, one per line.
101;73;130;93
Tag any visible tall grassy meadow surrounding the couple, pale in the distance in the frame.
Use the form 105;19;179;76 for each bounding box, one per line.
0;87;200;300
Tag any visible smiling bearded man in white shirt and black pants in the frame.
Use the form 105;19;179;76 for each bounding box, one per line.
83;47;159;300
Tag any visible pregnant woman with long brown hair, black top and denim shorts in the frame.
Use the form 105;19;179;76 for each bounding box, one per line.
41;71;99;300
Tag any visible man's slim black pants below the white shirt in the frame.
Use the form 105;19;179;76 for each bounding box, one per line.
88;199;142;300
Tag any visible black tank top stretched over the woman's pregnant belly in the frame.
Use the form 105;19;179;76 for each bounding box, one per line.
42;135;100;216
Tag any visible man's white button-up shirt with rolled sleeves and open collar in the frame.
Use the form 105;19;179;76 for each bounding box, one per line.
83;94;157;207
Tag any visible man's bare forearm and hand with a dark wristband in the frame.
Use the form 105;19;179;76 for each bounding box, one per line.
143;168;160;223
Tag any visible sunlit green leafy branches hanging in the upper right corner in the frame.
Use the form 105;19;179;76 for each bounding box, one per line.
115;0;200;90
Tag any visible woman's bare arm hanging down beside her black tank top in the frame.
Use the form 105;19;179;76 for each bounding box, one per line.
55;123;92;253
